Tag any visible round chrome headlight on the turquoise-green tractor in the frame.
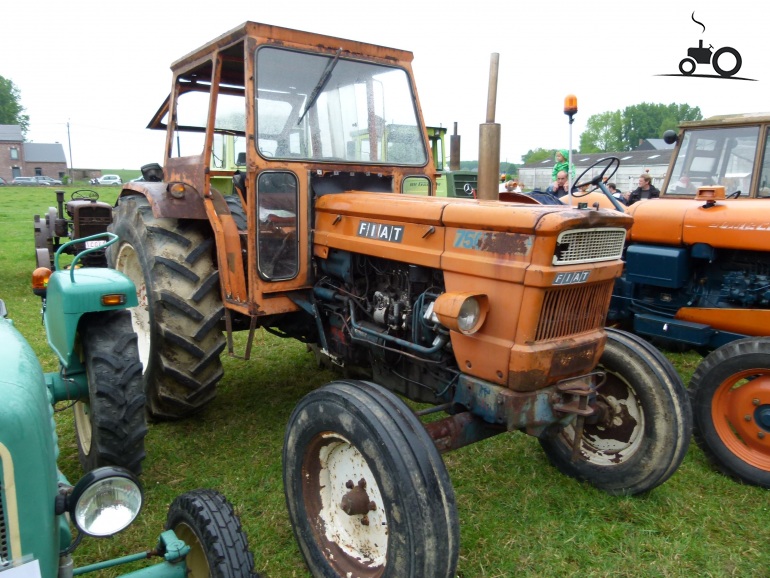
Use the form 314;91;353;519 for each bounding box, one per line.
70;467;143;536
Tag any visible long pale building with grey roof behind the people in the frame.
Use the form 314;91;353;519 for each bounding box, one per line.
519;146;673;192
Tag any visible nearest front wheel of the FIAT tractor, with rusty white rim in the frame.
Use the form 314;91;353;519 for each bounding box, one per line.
283;380;459;578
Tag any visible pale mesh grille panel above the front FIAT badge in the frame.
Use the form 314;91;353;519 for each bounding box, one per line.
553;228;626;265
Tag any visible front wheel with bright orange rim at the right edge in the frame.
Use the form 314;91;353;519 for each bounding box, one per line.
690;337;770;488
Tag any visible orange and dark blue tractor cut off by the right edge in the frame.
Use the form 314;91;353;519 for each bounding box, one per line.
609;114;770;488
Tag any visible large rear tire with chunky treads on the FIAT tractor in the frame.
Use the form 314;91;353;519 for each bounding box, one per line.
107;196;225;419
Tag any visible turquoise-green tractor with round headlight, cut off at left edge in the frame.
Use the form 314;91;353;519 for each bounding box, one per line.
0;234;255;578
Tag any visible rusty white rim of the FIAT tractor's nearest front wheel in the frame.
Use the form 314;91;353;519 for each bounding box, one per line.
318;434;388;570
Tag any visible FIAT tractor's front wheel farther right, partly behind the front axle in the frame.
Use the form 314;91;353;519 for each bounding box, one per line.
540;329;692;495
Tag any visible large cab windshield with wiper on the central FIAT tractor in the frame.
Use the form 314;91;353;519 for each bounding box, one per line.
256;47;427;166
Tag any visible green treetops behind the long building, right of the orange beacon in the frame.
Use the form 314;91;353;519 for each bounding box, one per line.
580;102;703;153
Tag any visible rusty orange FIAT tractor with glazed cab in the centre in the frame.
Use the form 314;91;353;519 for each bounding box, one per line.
107;22;691;577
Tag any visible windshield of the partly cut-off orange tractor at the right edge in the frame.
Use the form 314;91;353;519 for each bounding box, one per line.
665;126;759;196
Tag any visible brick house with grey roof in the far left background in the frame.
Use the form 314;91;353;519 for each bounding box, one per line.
0;124;67;182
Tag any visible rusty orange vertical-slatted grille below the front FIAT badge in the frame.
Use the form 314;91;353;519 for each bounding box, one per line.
535;279;615;341
